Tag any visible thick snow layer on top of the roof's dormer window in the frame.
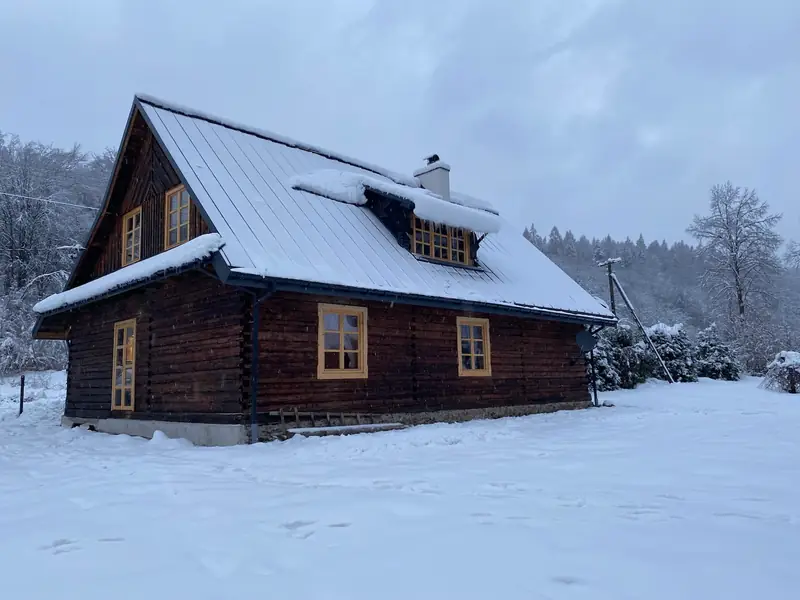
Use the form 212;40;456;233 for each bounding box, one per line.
289;169;502;233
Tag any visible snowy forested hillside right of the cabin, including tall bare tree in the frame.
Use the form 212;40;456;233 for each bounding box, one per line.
524;183;800;373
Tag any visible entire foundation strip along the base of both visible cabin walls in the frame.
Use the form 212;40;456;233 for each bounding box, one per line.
61;401;592;446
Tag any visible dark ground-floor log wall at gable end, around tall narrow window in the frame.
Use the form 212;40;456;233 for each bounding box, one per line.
65;273;245;422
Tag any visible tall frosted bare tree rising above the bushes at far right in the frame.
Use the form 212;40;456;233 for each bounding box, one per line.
688;182;782;318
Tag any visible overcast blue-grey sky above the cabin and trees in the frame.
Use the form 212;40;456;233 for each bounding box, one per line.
0;0;800;240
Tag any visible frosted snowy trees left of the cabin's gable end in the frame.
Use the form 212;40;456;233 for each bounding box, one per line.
0;131;115;374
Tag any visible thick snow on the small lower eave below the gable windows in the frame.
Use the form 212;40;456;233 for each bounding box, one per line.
33;233;224;315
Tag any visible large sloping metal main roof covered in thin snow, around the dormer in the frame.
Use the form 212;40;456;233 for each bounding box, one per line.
126;96;614;322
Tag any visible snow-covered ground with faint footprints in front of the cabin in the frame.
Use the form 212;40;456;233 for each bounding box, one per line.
0;374;800;600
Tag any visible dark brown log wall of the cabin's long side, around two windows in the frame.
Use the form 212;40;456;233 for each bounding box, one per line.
253;293;589;413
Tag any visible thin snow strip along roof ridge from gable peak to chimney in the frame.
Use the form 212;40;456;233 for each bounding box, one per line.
135;94;420;187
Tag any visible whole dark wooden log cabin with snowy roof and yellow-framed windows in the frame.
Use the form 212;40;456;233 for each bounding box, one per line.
34;96;615;445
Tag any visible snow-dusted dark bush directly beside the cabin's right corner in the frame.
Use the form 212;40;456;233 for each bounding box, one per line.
594;323;645;391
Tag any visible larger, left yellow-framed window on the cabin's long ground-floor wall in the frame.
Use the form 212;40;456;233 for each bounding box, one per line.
317;304;367;379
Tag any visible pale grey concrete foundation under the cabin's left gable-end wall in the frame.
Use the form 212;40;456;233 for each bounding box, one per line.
61;417;248;446
